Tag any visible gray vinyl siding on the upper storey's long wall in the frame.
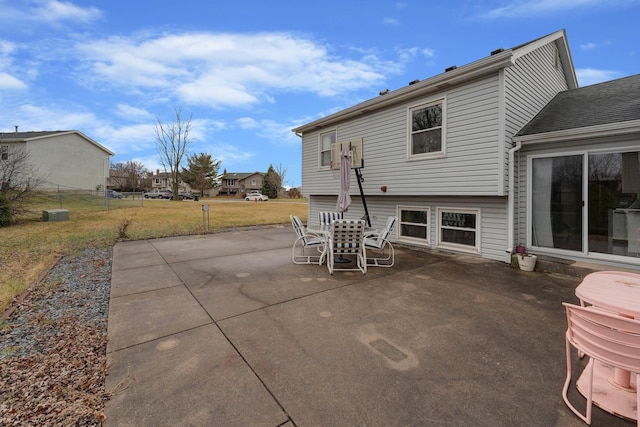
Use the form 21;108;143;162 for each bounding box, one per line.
302;73;502;196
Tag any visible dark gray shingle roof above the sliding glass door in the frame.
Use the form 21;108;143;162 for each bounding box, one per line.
516;74;640;136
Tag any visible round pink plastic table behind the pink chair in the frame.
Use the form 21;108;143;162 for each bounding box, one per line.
576;271;640;420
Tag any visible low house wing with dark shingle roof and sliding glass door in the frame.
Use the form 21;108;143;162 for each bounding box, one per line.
510;74;640;267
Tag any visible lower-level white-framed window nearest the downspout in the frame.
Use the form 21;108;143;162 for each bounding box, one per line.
437;208;480;253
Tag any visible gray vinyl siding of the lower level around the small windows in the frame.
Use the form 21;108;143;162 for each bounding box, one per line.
308;195;507;261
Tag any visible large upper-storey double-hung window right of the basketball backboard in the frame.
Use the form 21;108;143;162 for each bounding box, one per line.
407;99;445;159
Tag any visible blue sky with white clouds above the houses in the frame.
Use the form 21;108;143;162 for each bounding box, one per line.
0;0;640;186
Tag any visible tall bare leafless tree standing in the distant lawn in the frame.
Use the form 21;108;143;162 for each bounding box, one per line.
155;108;191;200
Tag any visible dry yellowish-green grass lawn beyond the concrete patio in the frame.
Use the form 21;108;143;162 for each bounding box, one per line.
0;200;308;312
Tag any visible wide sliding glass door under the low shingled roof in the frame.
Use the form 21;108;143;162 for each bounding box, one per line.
530;151;640;257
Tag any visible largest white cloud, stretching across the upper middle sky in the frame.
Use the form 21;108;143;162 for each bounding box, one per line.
76;33;399;108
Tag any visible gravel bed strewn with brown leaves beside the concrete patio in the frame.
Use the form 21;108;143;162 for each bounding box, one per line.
0;248;112;426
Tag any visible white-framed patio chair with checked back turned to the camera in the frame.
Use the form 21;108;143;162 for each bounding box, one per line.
327;219;367;274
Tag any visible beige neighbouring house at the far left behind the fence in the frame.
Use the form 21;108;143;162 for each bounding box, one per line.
0;129;114;191
